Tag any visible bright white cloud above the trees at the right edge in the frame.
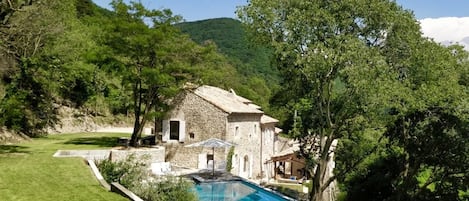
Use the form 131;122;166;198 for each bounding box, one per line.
420;17;469;50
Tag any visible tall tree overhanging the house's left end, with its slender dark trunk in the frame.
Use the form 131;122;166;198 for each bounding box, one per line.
106;0;235;146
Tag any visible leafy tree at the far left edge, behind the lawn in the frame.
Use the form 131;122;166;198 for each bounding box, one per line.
0;0;73;136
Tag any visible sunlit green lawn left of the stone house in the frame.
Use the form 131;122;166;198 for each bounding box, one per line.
0;133;128;201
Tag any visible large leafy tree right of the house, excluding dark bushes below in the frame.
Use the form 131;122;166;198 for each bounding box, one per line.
238;0;468;200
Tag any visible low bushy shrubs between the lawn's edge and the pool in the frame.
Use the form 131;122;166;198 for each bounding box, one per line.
97;155;197;201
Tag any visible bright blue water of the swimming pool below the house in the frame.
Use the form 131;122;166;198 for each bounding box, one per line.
195;181;286;201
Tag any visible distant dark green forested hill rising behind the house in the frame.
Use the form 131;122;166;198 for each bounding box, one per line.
177;18;279;85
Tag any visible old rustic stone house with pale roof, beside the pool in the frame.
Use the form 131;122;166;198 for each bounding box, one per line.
161;86;279;178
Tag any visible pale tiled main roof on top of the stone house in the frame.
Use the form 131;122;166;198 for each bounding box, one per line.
194;85;264;114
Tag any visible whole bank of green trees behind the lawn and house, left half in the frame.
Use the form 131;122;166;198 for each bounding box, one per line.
0;0;264;141
